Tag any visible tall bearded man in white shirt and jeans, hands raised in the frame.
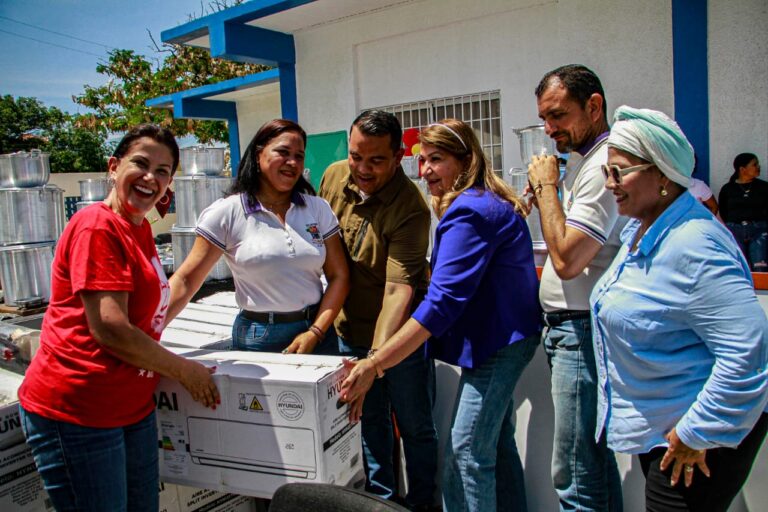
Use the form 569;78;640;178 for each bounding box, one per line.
528;65;623;511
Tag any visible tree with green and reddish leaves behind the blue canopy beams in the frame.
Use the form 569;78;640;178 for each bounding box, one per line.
72;0;268;143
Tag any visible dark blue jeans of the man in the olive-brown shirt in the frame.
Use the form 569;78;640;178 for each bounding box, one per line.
338;336;437;506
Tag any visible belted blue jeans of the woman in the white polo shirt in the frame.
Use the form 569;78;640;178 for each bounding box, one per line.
232;311;336;355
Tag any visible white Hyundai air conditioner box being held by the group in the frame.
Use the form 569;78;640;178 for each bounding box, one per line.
155;349;362;498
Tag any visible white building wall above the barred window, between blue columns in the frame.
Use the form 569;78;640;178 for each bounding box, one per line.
295;0;673;172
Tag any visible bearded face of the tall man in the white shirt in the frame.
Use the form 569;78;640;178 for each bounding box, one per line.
537;81;603;153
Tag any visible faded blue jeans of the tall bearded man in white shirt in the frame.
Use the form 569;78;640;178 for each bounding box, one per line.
543;318;623;511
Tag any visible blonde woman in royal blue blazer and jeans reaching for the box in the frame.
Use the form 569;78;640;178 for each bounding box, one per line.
341;119;541;512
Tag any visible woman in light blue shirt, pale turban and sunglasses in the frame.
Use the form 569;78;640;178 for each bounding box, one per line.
590;106;768;512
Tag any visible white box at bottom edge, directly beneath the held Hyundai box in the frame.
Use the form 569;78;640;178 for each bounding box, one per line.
159;482;257;512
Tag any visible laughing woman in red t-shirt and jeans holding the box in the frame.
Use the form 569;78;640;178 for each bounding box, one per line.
19;125;219;511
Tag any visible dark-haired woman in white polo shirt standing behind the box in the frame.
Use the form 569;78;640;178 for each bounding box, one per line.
168;119;349;353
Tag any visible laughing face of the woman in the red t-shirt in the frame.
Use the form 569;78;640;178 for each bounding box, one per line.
107;137;173;225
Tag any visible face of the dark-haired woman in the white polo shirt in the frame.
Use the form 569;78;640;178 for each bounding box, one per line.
259;132;304;199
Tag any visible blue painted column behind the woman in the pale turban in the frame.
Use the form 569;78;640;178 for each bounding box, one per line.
672;0;709;183
